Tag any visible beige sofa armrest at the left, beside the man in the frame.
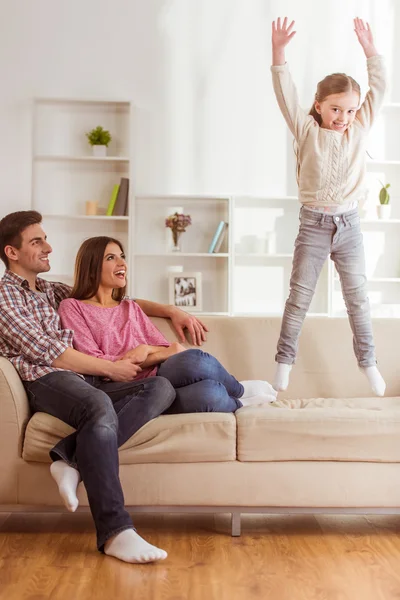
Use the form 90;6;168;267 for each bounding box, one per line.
0;357;31;459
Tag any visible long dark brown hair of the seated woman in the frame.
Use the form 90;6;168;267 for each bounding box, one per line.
70;235;126;301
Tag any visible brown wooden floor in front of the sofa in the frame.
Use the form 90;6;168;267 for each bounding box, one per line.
0;513;400;600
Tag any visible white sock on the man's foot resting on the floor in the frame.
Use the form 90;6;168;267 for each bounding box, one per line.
104;529;168;563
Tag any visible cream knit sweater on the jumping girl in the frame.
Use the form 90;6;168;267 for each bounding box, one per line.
271;56;386;210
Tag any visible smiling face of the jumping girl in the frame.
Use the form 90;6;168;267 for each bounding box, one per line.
315;91;360;133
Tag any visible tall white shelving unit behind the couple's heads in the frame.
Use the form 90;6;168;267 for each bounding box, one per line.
32;98;132;283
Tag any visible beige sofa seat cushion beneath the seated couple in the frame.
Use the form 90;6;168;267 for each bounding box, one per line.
22;412;236;465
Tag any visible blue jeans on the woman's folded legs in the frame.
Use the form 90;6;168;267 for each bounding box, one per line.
157;349;244;414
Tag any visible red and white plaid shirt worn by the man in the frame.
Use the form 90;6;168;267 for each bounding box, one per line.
0;269;73;381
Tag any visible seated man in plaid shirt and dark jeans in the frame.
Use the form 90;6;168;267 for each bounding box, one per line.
0;211;211;563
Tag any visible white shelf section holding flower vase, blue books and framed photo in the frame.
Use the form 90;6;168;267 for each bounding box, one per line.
132;195;231;315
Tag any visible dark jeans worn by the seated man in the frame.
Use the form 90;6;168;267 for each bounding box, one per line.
24;371;175;550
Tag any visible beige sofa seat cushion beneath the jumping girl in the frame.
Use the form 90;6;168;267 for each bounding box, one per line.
236;397;400;462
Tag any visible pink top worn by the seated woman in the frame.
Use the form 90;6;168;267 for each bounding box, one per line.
58;298;170;379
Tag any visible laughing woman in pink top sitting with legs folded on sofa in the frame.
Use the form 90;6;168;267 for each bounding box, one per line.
59;236;276;413
